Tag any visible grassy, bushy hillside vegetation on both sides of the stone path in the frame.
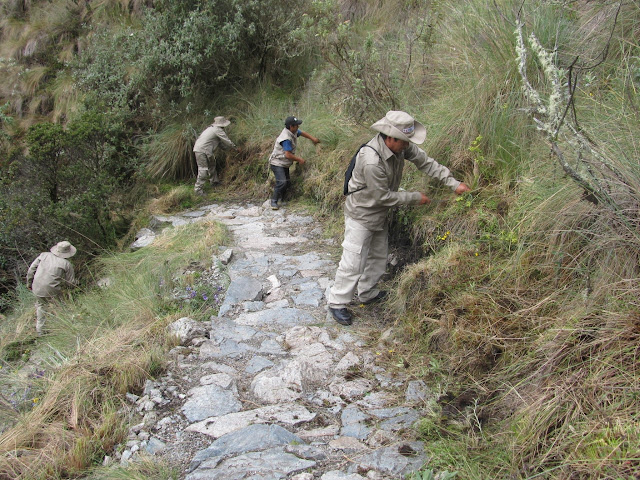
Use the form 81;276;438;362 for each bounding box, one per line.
0;0;640;479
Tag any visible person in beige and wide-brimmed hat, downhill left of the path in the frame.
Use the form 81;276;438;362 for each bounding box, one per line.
27;241;76;335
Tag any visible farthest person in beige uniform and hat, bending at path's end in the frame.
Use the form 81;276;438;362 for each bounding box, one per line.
193;117;236;195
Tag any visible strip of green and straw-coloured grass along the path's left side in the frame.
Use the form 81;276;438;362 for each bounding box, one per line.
0;222;224;479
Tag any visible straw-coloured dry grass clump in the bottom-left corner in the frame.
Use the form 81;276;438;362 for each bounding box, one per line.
0;324;152;479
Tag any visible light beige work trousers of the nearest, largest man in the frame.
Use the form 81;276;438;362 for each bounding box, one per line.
327;216;389;308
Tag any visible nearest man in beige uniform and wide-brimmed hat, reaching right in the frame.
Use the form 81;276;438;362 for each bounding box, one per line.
327;111;469;325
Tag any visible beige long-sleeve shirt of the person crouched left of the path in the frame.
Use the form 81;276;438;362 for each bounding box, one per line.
27;252;76;297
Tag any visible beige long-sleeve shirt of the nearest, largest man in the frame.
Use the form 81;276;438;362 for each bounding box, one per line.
344;134;460;230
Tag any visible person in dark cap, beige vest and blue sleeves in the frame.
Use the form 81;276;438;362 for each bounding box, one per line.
269;116;320;210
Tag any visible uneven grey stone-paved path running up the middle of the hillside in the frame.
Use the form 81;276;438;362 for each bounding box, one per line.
116;204;427;480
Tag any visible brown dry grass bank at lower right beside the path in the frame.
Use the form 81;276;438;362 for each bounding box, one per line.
389;225;640;478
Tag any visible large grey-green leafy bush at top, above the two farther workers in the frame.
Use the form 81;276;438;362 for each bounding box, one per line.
75;0;318;122
